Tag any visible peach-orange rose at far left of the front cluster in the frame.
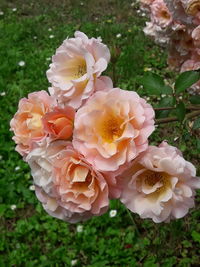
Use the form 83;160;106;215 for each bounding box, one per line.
10;91;56;156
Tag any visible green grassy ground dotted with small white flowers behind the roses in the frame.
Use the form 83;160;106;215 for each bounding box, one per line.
0;0;200;267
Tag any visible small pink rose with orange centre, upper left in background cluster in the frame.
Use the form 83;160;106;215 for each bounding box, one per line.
151;0;172;28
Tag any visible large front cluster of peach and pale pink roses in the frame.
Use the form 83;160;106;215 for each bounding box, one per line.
10;32;200;223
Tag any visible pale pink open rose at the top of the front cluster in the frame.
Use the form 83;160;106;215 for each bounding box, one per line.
47;31;111;109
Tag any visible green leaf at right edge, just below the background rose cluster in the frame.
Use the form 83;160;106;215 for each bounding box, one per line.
175;71;200;93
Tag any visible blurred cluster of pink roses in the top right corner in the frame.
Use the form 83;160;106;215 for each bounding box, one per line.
140;0;200;94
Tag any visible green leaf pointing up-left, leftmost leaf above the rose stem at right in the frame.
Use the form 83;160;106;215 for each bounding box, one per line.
139;72;172;95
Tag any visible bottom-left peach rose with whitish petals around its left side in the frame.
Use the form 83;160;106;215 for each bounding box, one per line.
28;141;109;223
